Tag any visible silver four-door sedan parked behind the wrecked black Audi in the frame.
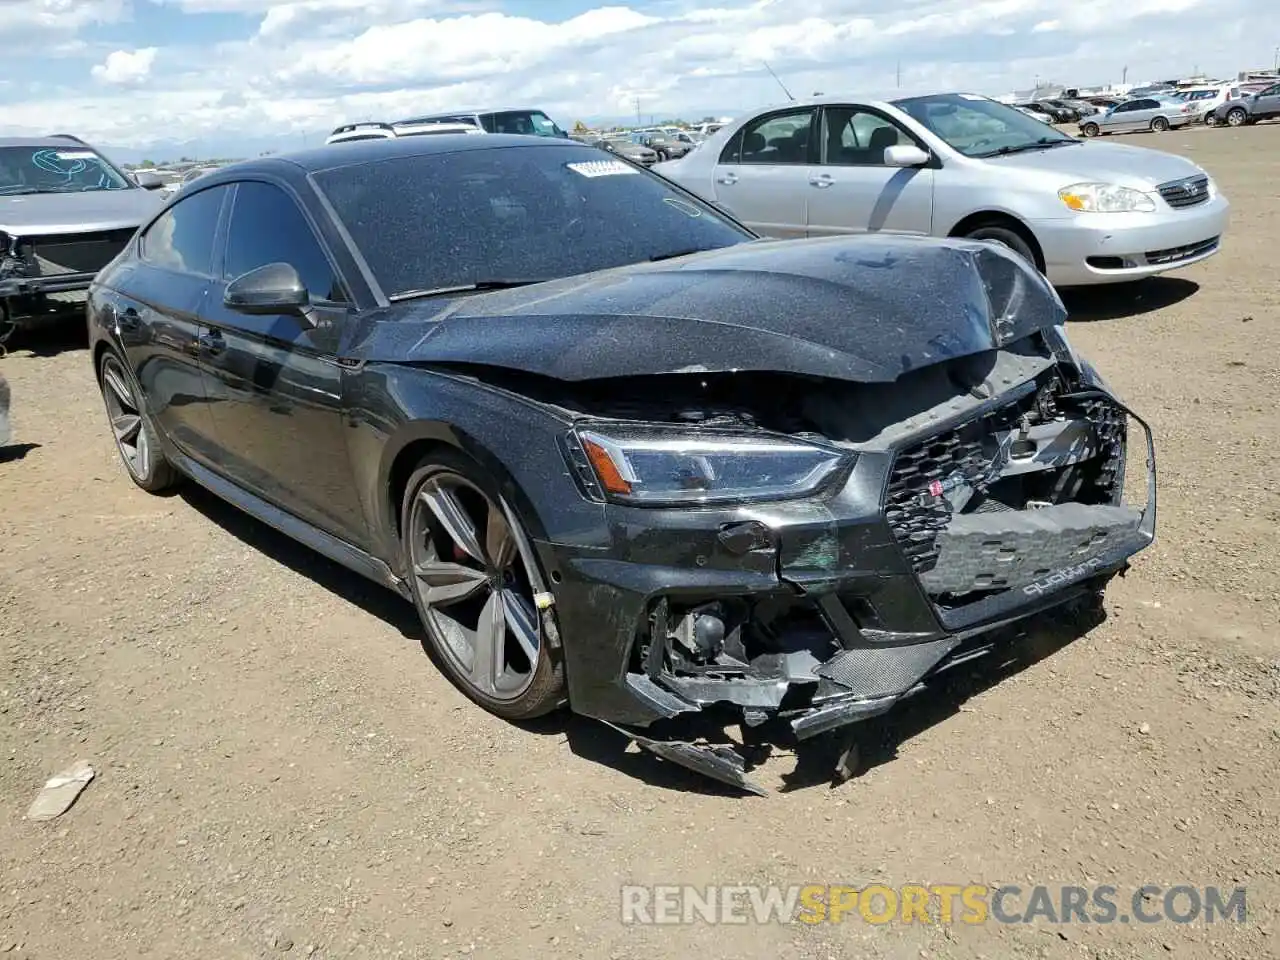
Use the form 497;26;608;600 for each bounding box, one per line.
654;93;1229;287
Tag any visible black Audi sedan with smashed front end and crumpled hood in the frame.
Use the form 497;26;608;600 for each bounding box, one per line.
88;134;1155;788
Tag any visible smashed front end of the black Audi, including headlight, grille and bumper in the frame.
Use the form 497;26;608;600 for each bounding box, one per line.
535;332;1156;790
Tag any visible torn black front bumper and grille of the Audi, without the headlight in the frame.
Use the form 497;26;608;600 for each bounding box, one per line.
539;384;1156;790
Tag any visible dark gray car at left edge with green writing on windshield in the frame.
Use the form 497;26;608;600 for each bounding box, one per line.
0;134;164;342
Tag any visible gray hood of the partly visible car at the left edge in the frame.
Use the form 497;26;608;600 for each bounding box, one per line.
0;187;164;237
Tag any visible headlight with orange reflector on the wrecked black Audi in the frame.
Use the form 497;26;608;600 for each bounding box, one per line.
567;426;852;506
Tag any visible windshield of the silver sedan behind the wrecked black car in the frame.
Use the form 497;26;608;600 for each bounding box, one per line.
893;93;1079;157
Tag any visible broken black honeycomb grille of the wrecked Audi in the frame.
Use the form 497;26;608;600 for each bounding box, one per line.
884;380;1128;573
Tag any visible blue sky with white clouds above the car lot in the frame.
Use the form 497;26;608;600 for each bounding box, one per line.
0;0;1280;148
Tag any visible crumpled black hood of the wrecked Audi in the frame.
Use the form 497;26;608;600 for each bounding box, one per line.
343;236;1066;381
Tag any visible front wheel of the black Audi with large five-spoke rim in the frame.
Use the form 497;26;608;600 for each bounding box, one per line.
403;458;564;719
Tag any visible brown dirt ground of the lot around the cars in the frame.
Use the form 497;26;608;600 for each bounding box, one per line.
0;124;1280;960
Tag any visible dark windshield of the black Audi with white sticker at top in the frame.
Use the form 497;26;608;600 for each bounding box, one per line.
315;143;754;297
